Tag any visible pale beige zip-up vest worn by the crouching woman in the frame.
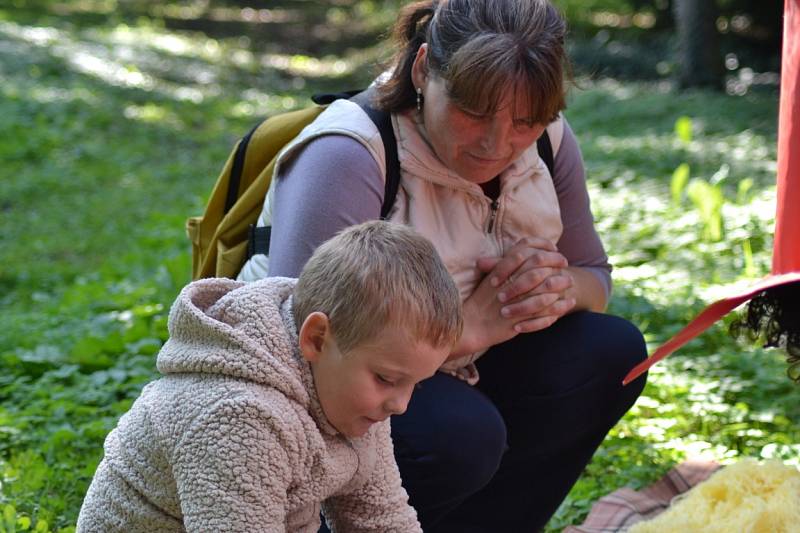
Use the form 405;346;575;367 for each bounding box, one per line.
239;100;563;382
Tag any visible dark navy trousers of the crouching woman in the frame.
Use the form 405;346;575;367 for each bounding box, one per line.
391;311;646;533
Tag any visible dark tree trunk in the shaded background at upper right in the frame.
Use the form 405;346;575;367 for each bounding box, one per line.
673;0;723;88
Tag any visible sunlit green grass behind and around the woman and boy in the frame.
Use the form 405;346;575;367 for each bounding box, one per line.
0;5;800;531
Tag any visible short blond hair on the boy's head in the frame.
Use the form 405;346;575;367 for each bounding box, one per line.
293;221;463;353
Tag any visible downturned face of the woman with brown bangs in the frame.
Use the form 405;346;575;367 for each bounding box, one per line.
412;45;545;184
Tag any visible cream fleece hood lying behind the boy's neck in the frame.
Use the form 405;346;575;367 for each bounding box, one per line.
156;278;313;405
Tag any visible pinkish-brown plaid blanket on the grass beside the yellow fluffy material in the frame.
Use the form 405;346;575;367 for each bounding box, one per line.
563;460;720;533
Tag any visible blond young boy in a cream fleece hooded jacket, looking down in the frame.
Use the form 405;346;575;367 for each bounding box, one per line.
78;218;462;533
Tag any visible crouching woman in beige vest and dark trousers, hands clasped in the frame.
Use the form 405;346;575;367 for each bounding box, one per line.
241;0;645;532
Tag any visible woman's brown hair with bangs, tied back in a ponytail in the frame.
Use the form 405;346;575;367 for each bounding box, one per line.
376;0;569;124
